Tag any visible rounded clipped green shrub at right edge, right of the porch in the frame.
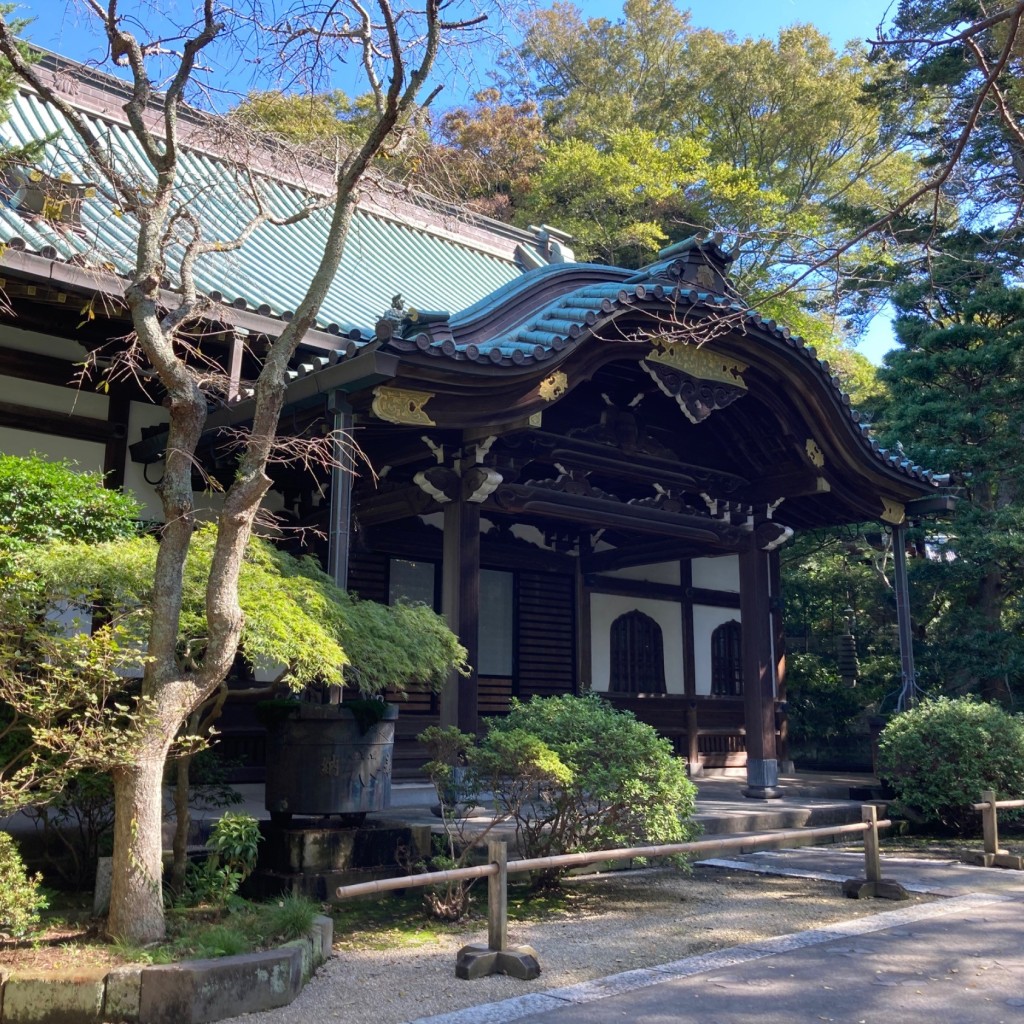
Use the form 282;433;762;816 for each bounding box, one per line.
879;697;1024;830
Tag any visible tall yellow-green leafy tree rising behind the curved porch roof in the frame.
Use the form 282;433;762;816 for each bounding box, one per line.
507;0;920;395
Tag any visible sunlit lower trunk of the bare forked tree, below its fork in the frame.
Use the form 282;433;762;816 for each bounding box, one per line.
106;726;168;944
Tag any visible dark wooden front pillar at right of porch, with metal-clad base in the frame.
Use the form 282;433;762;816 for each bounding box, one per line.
739;530;781;800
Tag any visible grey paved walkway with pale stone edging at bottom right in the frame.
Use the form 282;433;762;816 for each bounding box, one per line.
405;848;1024;1024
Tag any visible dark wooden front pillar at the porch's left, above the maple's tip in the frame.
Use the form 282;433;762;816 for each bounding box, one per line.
440;499;480;732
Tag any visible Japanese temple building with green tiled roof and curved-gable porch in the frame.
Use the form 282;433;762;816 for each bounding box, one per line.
0;56;947;798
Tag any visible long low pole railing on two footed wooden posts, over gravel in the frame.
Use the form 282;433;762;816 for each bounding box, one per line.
335;804;892;978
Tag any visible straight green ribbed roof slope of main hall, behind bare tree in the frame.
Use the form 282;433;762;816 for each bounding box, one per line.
0;82;522;332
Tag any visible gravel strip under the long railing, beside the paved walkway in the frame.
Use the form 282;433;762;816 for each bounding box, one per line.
218;867;927;1024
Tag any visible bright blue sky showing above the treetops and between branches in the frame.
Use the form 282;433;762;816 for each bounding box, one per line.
17;0;895;362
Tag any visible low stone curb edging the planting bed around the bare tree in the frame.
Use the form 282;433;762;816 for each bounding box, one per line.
0;914;334;1024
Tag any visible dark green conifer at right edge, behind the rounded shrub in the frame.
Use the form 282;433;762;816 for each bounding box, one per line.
882;228;1024;700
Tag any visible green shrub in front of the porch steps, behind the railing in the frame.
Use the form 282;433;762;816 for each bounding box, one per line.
471;694;696;885
